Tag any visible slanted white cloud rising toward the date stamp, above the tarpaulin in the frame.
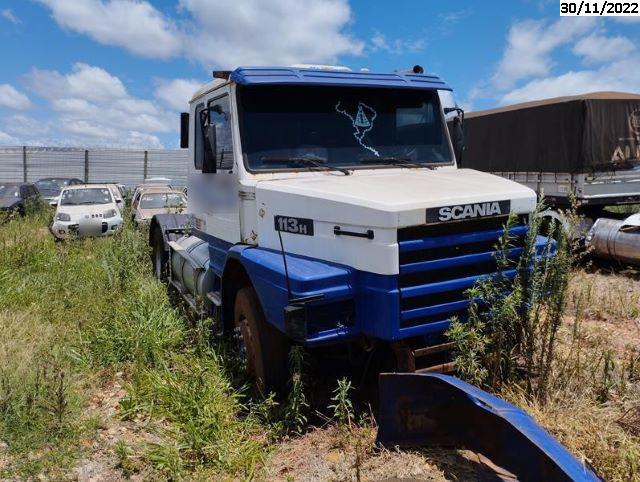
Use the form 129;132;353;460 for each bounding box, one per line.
492;17;596;89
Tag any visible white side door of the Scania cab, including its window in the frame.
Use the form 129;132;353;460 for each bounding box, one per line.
189;93;240;243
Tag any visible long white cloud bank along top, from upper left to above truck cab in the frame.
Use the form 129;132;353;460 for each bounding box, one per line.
39;0;364;68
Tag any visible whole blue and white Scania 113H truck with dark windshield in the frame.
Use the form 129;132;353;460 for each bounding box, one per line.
149;67;536;387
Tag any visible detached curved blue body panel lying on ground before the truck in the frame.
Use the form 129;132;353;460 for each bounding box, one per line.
378;373;602;482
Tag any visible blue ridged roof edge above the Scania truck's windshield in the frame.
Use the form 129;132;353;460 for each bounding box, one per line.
193;67;452;99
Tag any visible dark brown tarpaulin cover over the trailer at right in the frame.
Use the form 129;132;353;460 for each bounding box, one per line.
462;92;640;173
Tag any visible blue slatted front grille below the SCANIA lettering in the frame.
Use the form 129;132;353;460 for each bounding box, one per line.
398;216;528;331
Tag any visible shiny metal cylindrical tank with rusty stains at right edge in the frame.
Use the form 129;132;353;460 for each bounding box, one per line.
586;218;640;264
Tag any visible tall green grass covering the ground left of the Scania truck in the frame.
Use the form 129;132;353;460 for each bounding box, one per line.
0;208;266;478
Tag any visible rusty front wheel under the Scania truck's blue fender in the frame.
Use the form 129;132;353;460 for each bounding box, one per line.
234;287;289;394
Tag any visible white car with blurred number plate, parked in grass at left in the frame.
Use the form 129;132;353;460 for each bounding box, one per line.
51;184;122;239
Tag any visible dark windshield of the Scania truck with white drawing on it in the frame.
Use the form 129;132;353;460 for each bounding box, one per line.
239;86;453;171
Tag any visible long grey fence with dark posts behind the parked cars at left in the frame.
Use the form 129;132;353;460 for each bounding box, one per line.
0;146;188;187
